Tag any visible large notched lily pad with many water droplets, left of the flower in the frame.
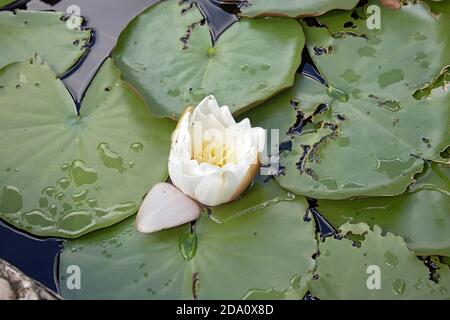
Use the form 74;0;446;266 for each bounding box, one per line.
0;56;174;238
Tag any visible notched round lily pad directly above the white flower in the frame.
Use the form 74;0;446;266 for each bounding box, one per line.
113;0;304;117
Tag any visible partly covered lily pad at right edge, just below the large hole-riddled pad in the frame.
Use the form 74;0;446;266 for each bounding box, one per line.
318;165;450;256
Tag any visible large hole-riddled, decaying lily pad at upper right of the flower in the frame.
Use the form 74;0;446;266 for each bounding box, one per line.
253;4;450;199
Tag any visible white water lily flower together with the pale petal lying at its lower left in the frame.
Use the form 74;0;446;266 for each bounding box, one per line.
136;96;266;233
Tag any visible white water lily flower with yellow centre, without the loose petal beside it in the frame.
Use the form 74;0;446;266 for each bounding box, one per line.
169;96;266;206
